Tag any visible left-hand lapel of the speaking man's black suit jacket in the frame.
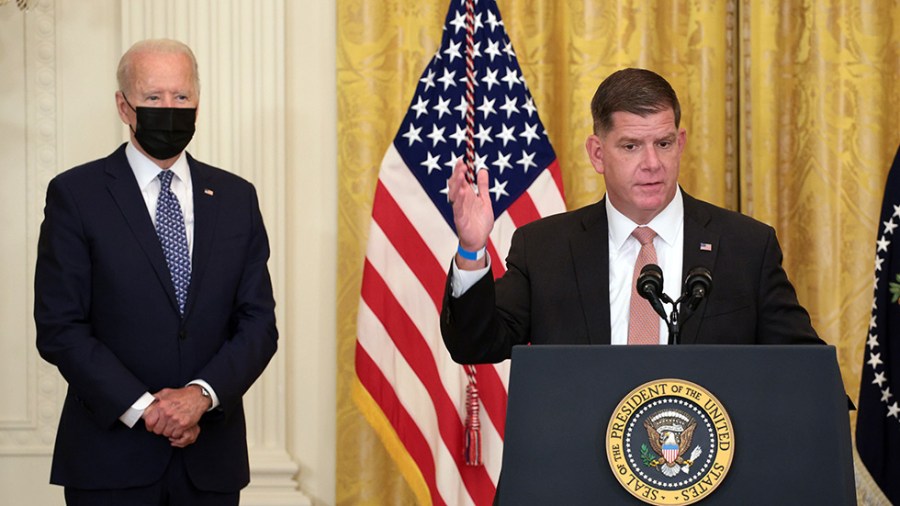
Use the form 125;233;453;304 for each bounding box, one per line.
569;200;610;344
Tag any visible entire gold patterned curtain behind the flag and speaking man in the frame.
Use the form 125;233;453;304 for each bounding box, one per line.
336;0;900;505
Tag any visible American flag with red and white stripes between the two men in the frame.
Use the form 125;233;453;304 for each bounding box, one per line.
354;0;565;505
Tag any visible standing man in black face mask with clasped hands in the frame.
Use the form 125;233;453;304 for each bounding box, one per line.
34;40;277;506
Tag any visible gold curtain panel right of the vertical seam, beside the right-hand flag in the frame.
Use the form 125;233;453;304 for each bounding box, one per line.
740;0;900;397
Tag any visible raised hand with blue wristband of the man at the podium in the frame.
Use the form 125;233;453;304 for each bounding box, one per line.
447;158;494;270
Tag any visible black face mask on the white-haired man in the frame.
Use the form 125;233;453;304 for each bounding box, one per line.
123;95;197;160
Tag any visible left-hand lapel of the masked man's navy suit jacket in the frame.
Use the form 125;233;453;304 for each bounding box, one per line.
106;144;178;311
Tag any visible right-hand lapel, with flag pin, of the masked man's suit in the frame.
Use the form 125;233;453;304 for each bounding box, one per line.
184;155;219;318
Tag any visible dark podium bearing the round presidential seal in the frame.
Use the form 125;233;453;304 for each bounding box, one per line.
498;345;856;506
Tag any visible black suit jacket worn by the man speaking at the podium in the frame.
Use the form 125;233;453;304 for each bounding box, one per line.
441;191;822;363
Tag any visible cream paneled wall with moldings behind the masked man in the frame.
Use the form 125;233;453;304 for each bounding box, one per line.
0;0;337;506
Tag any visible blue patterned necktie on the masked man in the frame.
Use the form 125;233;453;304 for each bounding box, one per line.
156;170;191;315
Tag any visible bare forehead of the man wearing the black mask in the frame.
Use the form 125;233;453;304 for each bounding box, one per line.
131;51;195;92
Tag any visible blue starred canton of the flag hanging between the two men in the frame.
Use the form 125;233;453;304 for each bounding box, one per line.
394;0;556;230
